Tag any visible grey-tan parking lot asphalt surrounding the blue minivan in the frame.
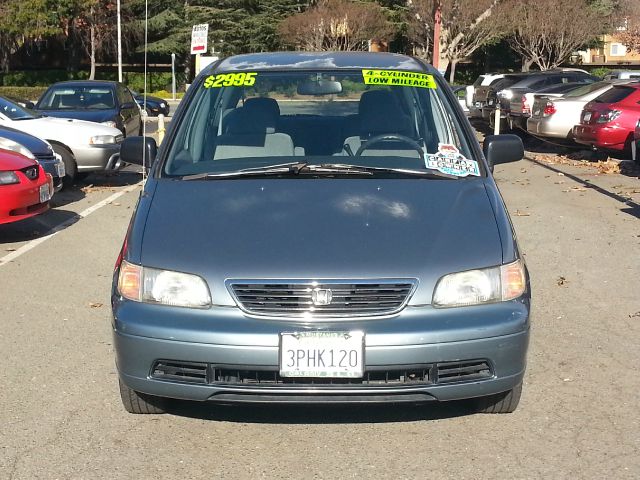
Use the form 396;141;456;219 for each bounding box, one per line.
0;155;640;479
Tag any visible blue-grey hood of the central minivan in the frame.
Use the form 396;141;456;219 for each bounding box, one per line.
140;178;503;305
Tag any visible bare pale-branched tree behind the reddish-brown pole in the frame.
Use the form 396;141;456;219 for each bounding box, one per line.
408;0;503;81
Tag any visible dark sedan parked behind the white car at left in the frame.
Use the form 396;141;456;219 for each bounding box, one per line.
35;80;142;137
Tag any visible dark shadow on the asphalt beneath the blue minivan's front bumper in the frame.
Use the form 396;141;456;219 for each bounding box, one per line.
162;400;476;425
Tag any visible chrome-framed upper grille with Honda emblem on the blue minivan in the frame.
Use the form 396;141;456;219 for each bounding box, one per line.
229;279;416;317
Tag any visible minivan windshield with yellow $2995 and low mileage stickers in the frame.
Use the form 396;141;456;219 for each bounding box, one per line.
162;69;482;178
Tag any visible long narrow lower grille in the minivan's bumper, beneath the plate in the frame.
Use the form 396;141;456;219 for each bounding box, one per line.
151;360;493;387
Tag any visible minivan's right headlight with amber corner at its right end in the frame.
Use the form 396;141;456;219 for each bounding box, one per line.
433;260;526;307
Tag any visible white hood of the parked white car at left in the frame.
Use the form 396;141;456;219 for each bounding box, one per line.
5;117;122;145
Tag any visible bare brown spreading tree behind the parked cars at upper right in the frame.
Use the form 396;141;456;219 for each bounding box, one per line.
505;0;607;71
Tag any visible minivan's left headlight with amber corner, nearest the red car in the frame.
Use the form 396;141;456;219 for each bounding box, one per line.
118;261;211;308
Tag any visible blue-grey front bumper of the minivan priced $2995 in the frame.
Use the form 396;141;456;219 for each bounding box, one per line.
114;299;529;403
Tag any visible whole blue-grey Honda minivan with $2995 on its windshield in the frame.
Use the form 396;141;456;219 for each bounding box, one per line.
111;52;530;413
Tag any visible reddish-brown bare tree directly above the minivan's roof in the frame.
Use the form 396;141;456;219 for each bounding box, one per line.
279;0;393;51
